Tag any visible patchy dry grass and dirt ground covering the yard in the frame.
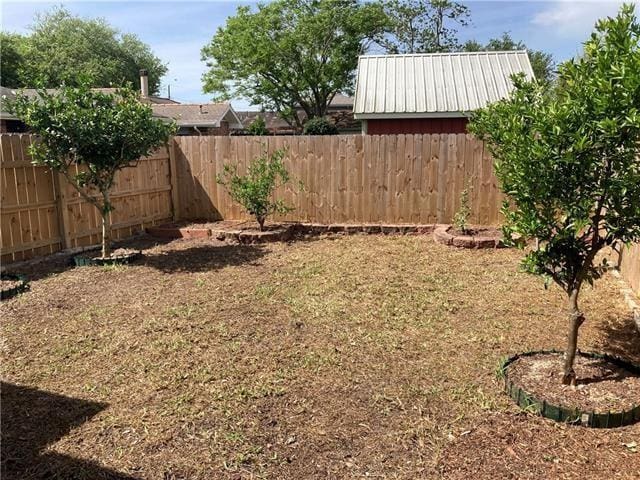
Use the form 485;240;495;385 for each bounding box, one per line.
0;236;640;480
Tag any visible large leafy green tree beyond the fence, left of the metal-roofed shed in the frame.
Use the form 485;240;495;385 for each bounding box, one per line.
202;0;384;128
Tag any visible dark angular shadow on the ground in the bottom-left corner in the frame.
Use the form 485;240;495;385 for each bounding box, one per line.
0;382;134;480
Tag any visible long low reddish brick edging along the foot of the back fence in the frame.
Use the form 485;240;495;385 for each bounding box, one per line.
147;222;436;244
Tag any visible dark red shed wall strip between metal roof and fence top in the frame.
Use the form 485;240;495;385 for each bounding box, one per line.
367;117;469;135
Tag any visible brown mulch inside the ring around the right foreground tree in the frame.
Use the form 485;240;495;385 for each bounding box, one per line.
507;353;640;413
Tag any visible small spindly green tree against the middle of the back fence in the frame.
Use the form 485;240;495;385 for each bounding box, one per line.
217;150;293;231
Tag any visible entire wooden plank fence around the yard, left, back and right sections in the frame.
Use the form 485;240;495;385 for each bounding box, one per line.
0;129;640;294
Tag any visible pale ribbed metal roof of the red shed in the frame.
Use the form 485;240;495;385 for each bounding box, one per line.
353;50;534;119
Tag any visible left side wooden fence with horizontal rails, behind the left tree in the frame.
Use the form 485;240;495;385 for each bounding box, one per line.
0;134;172;263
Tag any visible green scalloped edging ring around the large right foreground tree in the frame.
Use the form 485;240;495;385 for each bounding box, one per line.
500;350;640;428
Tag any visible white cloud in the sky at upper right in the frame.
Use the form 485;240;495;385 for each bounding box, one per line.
531;0;637;36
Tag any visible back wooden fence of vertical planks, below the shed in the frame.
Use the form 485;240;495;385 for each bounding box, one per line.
174;134;502;225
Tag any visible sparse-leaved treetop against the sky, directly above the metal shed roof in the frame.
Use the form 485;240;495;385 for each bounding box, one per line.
378;0;469;53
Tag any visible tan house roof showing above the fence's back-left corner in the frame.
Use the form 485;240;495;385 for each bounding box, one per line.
151;103;242;128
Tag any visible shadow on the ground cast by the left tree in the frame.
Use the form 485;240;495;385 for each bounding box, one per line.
140;242;268;273
